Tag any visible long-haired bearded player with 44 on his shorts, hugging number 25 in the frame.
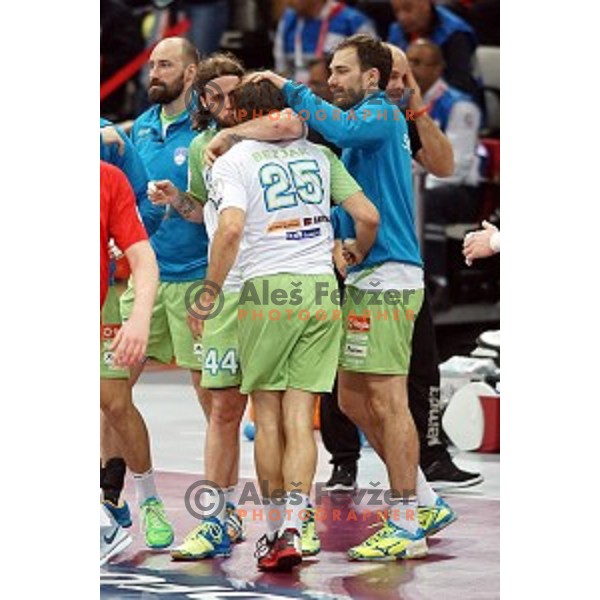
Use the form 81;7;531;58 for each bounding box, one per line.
142;53;314;561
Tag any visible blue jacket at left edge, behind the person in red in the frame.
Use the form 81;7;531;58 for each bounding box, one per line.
100;118;165;235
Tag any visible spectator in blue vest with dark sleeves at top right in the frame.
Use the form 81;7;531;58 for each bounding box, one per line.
388;0;481;102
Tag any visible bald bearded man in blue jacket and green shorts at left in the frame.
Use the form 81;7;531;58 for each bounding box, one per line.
101;37;208;548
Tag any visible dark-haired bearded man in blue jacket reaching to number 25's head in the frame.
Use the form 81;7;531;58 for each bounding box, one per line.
247;34;456;560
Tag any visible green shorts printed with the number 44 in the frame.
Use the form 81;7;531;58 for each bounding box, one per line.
202;292;242;389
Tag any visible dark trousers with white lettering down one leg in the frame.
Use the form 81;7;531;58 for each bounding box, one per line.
320;291;449;467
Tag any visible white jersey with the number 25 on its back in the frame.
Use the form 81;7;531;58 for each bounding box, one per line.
206;139;333;281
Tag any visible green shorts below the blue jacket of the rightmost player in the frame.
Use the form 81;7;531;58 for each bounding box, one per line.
340;285;424;375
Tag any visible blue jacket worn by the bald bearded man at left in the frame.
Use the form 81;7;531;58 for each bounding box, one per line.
131;105;208;282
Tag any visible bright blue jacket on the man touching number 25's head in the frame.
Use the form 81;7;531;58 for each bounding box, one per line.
283;82;423;271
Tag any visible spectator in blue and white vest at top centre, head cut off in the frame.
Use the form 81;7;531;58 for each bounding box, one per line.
274;0;377;83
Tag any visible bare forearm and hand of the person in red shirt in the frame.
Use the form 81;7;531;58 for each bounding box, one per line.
111;241;158;367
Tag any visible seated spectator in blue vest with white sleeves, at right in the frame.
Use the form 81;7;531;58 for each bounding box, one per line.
406;39;481;310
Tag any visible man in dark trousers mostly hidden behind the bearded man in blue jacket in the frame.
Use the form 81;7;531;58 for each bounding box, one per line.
322;44;483;492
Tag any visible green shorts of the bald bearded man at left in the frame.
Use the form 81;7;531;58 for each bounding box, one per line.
121;279;202;371
